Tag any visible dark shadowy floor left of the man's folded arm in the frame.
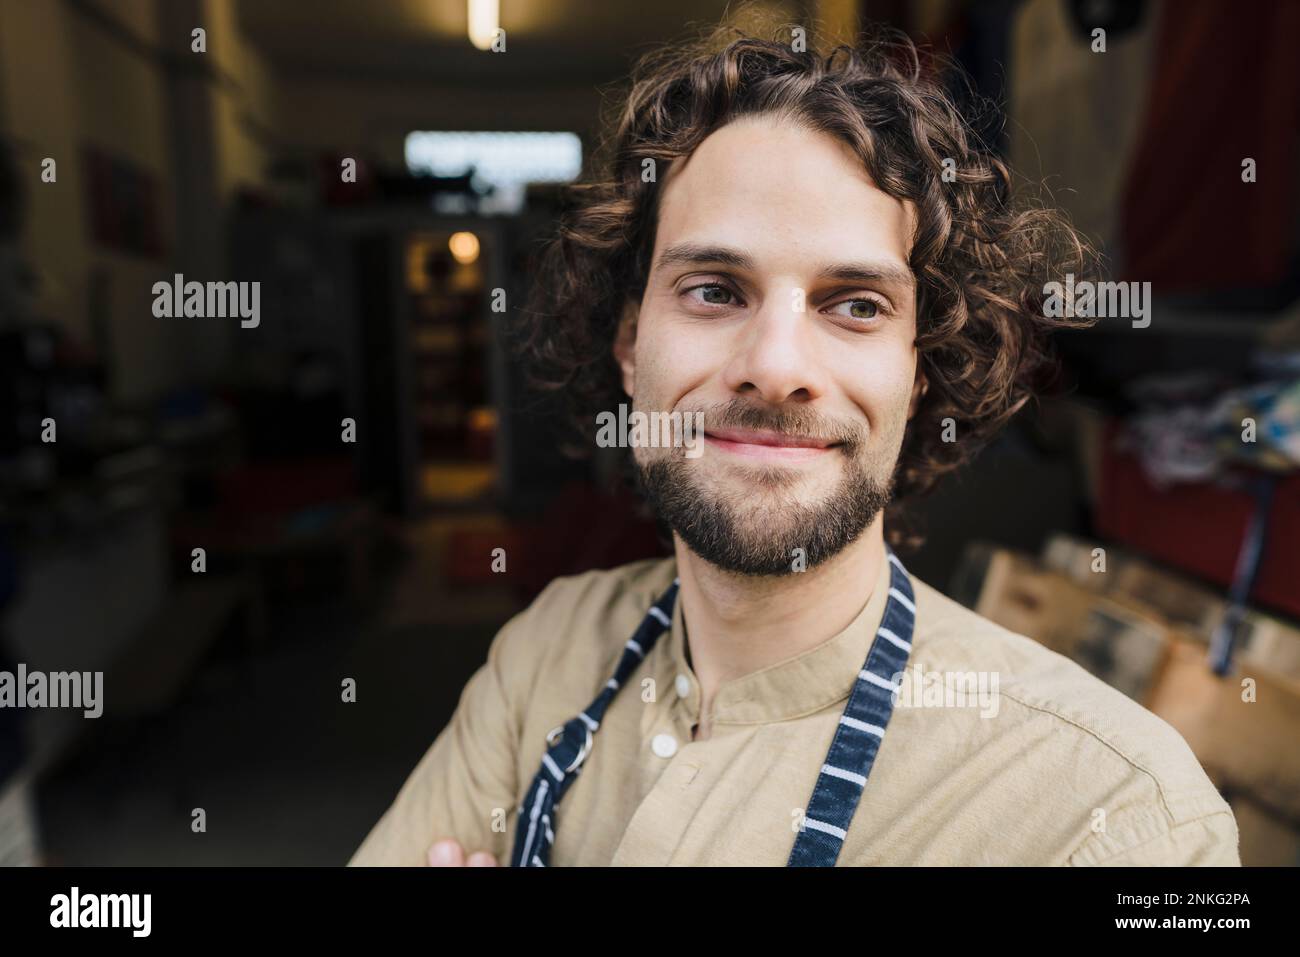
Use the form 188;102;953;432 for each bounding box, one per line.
38;516;517;866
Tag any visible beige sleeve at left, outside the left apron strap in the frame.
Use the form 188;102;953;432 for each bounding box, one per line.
348;614;529;867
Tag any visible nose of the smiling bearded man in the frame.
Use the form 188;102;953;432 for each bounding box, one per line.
723;286;826;404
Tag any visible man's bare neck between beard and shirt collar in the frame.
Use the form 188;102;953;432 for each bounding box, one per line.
673;515;885;718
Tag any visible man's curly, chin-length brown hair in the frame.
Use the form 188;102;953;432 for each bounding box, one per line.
519;16;1096;542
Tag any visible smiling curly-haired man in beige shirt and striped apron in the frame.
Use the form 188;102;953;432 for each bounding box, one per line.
352;27;1240;866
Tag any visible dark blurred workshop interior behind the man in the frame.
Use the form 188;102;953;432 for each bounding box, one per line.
0;0;1300;865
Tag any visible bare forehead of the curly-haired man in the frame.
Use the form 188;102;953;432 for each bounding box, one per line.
655;116;915;274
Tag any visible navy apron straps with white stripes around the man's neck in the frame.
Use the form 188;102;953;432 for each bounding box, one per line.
510;546;917;867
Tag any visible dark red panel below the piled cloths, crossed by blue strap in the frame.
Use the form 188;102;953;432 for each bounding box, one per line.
1097;428;1300;616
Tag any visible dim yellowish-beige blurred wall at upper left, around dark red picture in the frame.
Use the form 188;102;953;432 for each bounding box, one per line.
0;0;274;400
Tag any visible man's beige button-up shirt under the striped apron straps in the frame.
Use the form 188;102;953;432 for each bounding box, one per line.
350;558;1240;866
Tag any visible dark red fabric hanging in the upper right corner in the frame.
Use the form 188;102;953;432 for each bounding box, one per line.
1118;0;1300;293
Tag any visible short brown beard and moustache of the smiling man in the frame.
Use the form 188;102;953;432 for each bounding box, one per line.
636;399;897;576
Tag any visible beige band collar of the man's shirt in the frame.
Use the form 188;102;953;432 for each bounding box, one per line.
660;555;889;724
